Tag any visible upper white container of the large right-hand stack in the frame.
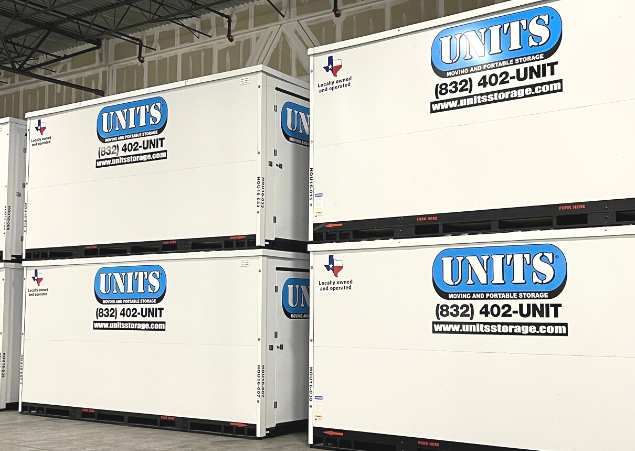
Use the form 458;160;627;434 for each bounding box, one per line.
310;0;635;241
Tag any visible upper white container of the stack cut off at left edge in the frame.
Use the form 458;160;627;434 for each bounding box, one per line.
0;117;26;261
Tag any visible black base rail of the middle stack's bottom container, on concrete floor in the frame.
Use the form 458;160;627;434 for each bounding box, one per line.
20;403;308;439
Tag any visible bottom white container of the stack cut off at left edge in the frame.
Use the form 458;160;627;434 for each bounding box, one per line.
0;262;23;410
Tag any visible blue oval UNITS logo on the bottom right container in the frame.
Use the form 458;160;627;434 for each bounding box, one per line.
432;244;567;299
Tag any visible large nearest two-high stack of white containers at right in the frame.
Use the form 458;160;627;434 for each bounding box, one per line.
309;0;635;451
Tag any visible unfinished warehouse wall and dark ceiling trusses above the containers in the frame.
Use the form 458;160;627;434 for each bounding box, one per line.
0;0;501;118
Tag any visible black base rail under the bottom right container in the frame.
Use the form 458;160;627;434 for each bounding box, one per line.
311;427;524;451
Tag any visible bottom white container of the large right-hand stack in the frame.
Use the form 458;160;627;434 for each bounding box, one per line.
309;230;635;451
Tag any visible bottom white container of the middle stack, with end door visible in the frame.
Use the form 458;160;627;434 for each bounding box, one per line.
20;250;309;437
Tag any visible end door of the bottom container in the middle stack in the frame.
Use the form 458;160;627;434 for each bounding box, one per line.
274;267;309;424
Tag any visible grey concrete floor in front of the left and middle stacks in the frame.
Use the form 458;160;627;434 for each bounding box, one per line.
0;411;309;451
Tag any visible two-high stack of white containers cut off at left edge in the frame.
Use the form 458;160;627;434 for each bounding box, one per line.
0;118;26;409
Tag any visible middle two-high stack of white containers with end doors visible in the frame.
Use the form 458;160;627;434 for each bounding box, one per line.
21;67;309;437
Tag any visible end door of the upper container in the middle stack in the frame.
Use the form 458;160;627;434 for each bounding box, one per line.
274;89;310;241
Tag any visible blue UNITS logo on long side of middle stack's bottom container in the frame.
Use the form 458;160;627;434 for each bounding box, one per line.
94;265;167;304
